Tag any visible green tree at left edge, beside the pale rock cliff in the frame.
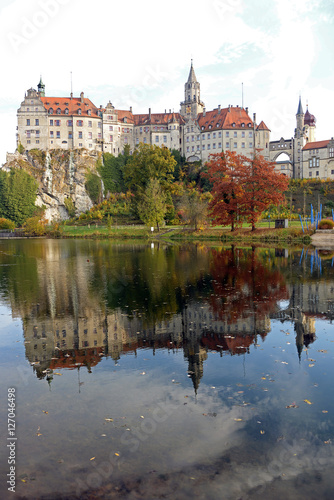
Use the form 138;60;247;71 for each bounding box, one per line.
0;168;38;225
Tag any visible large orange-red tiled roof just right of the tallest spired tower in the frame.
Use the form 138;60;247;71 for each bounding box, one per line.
197;106;253;130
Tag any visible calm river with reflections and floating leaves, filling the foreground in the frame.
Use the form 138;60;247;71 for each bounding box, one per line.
0;240;334;500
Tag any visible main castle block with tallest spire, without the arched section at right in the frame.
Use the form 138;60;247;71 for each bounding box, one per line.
17;62;270;162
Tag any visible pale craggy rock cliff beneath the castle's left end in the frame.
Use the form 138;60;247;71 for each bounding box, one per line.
3;149;102;222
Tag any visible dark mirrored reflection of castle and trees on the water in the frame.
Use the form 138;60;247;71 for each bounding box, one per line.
0;240;334;391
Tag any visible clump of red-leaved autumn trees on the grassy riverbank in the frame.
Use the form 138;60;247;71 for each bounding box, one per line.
204;151;289;231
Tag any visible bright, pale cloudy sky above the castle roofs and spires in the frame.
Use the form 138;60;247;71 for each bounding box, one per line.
0;0;334;164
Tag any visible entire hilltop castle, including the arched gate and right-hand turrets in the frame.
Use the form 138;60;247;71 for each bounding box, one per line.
17;62;334;179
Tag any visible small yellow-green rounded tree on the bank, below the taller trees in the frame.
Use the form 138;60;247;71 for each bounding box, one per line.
137;179;167;231
